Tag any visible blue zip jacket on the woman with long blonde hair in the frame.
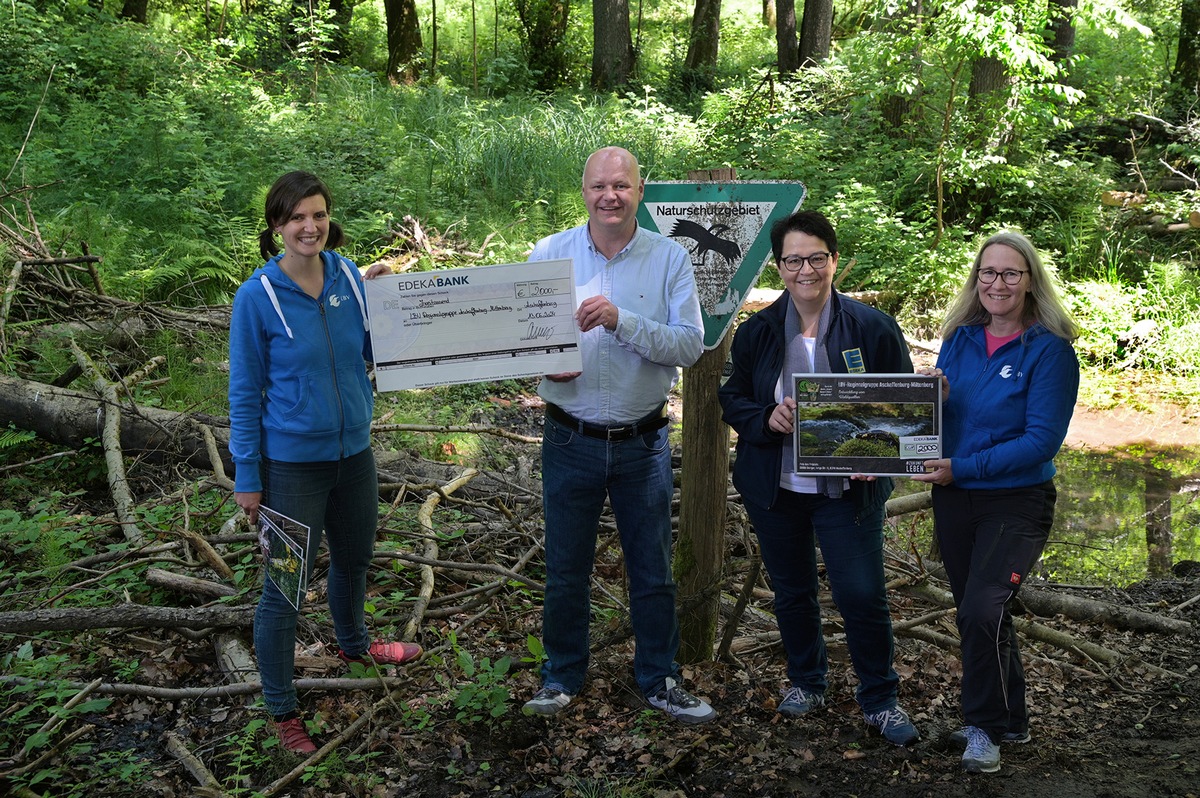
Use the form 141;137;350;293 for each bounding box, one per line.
937;324;1079;488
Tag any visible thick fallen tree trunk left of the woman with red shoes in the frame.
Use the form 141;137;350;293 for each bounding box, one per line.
0;374;233;470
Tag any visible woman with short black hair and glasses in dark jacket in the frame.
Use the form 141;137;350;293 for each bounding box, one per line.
719;211;920;745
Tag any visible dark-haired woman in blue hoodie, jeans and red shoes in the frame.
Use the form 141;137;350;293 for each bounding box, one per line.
229;172;421;754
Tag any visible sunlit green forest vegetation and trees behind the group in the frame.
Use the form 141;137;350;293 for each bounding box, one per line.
0;0;1200;794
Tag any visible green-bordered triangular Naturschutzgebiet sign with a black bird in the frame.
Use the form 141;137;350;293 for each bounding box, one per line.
637;180;805;349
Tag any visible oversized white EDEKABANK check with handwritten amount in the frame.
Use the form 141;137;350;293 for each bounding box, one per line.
366;258;583;391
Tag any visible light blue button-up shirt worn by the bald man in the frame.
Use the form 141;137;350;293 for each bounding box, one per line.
529;224;704;426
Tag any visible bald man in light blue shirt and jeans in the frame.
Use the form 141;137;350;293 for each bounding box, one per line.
523;146;716;724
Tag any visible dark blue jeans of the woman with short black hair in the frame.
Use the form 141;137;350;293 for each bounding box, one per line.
746;488;900;713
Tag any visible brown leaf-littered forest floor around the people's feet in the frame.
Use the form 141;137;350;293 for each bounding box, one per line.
9;393;1200;798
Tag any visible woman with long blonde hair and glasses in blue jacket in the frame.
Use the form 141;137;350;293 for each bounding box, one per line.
913;233;1079;773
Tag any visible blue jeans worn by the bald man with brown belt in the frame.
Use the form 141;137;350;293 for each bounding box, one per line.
541;418;679;695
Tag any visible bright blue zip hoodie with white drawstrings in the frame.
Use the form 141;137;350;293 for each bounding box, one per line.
229;251;374;492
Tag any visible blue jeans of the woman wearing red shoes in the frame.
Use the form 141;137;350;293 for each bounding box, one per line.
254;448;379;716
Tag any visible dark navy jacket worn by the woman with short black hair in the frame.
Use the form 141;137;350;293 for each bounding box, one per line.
718;292;912;508
